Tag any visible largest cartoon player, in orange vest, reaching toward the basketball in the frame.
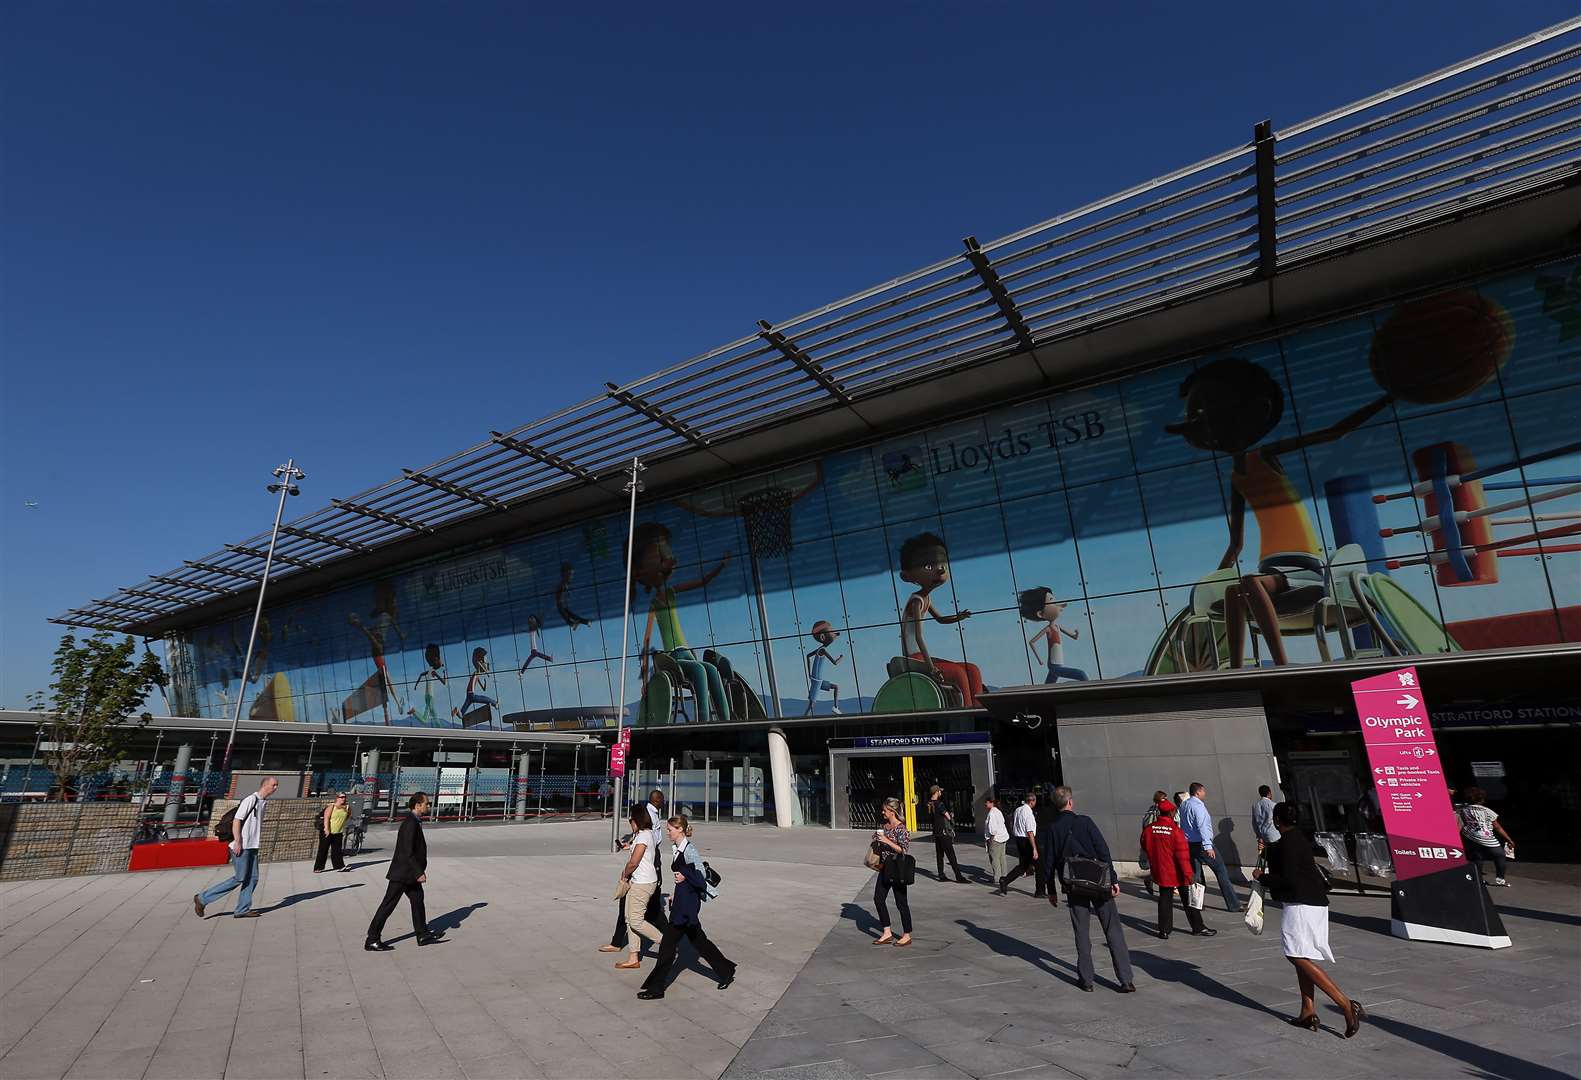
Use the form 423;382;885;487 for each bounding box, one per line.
1164;356;1393;667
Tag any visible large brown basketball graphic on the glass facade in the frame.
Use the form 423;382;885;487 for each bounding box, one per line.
1368;289;1515;405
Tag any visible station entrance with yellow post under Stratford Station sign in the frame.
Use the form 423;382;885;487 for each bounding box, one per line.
828;732;994;832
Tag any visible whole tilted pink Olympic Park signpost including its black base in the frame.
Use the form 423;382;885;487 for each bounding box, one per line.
1350;667;1510;949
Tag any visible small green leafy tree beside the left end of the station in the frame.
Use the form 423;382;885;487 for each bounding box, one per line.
28;631;169;800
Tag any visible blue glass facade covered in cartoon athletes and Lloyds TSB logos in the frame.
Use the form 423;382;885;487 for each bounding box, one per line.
171;262;1581;729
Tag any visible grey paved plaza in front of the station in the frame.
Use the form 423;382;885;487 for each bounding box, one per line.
0;822;1581;1080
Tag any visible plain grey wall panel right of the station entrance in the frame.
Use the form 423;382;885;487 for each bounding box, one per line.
1056;693;1274;867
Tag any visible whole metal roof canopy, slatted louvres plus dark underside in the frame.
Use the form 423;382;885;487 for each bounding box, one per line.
51;17;1581;636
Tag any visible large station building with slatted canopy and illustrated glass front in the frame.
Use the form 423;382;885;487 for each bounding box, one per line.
15;22;1581;859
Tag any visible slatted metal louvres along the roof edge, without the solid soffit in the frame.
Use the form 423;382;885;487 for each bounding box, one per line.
54;17;1581;631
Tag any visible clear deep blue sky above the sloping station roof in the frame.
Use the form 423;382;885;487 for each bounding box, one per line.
0;0;1573;707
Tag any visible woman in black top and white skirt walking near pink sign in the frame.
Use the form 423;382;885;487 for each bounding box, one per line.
1252;803;1368;1039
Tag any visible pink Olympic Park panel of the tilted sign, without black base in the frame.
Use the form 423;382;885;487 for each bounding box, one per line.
1350;667;1466;881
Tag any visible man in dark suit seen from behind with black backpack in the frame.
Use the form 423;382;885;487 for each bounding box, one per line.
1045;786;1137;993
